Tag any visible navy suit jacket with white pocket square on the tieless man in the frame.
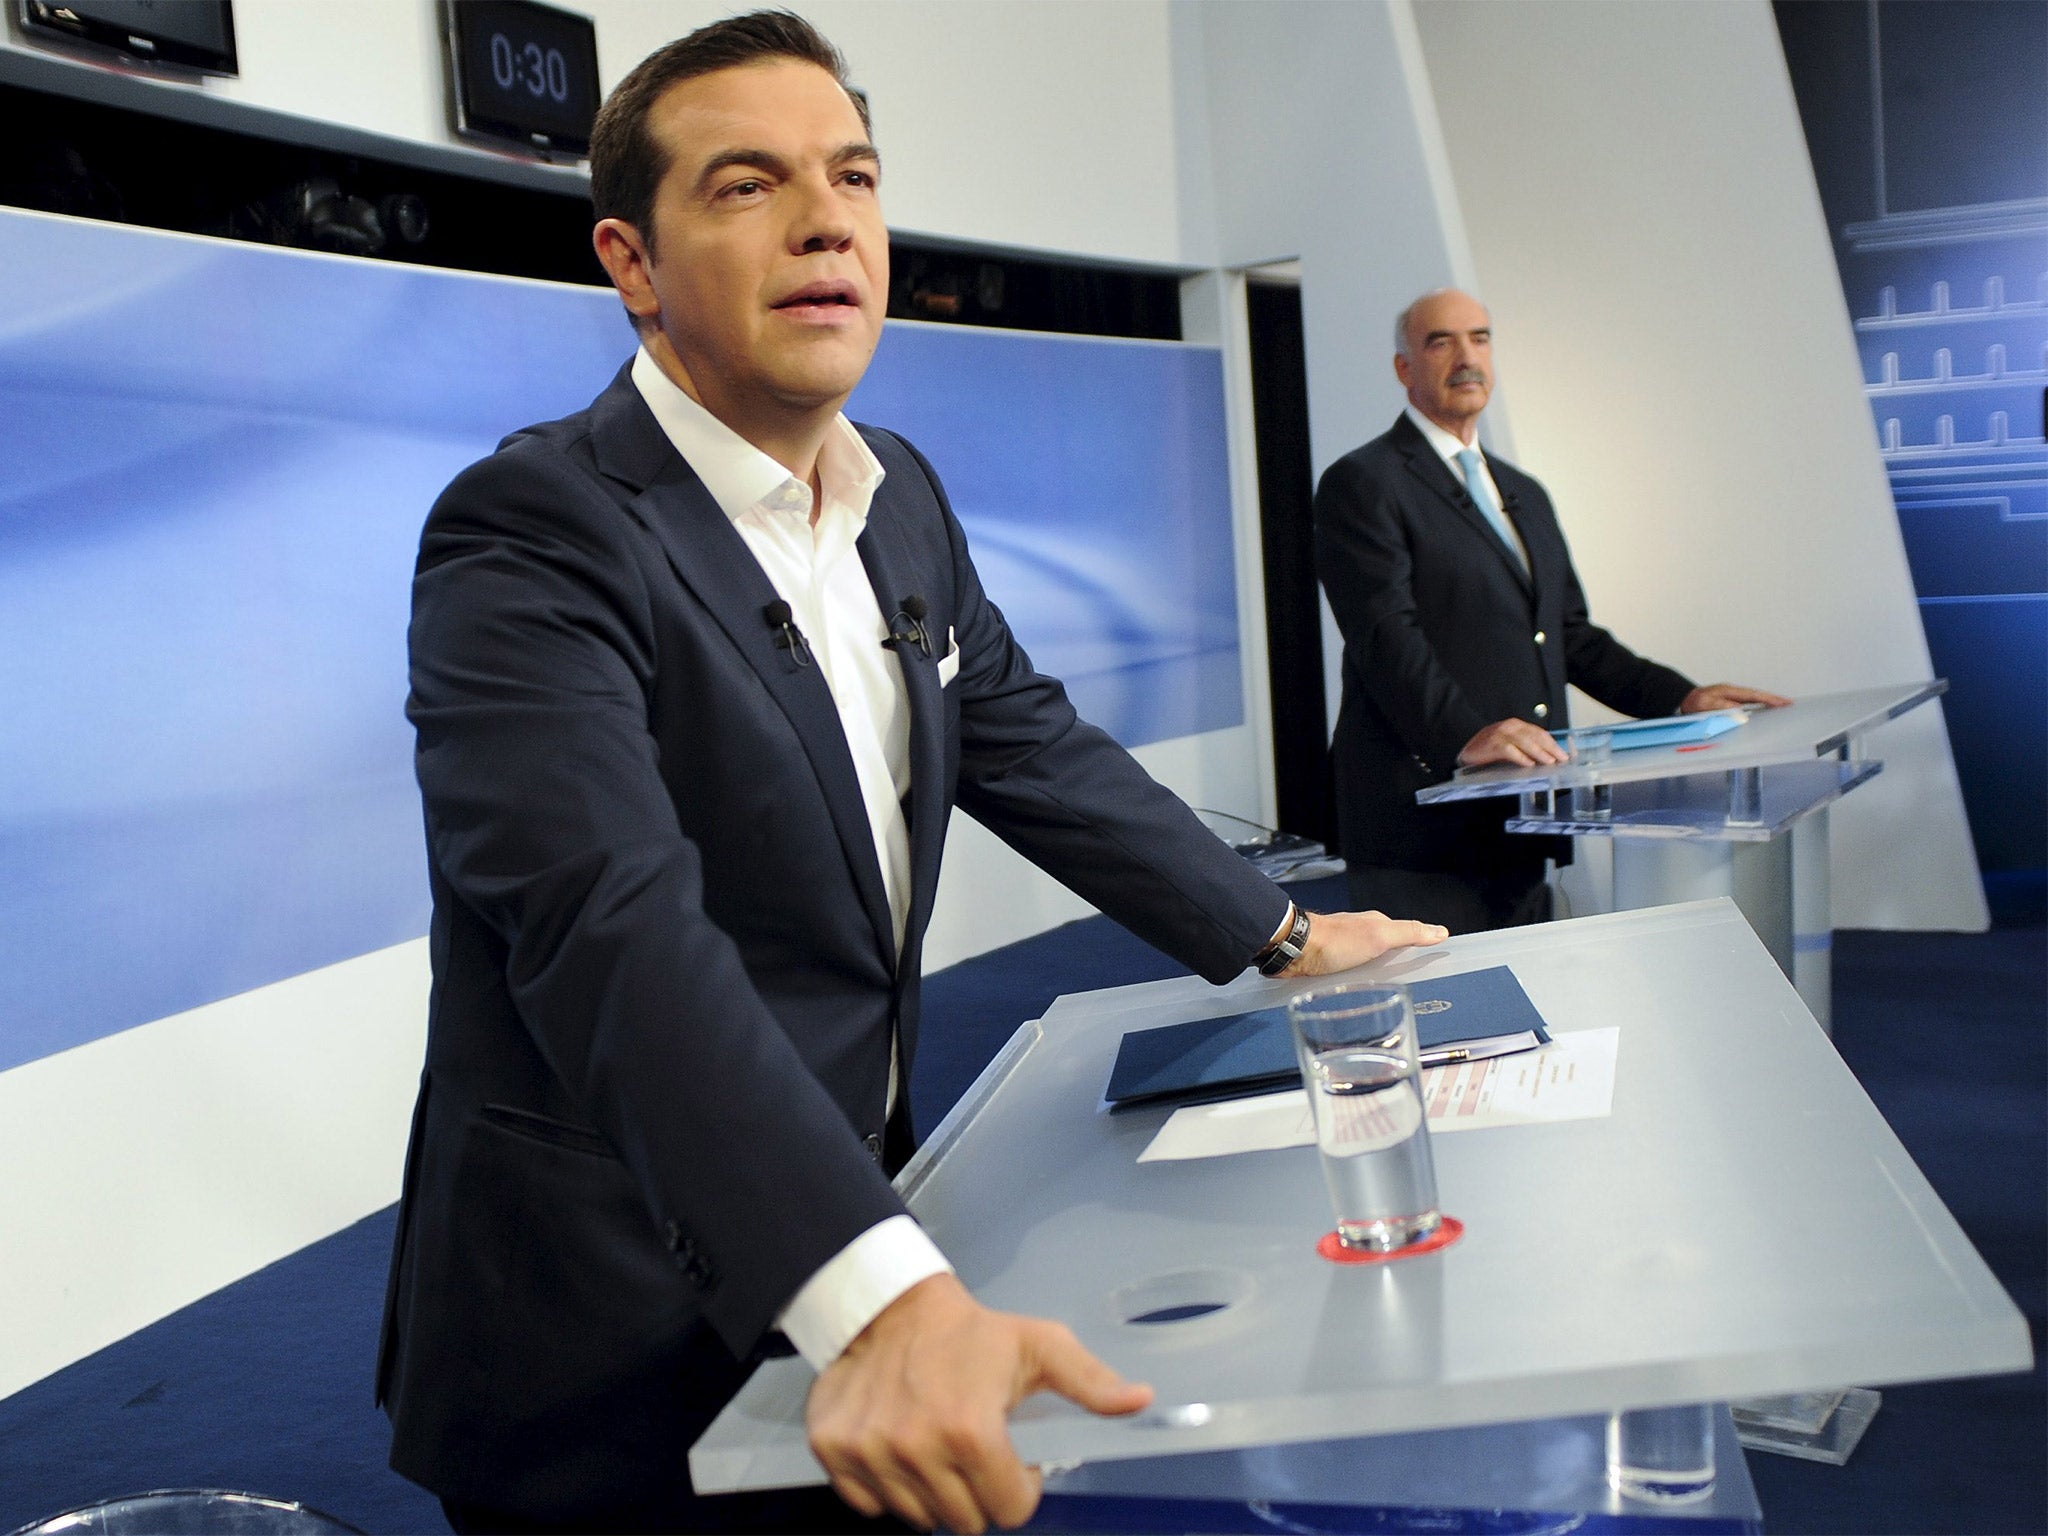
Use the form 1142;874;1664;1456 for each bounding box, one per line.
377;373;1286;1522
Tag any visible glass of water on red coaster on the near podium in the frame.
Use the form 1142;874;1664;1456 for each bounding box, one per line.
1286;981;1444;1253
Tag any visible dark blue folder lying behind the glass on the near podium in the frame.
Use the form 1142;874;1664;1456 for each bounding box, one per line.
1104;965;1550;1108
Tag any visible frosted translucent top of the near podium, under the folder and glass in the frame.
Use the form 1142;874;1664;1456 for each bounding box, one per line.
690;899;2032;1493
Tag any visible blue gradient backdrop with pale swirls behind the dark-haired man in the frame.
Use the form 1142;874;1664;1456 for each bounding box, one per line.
0;211;1243;1069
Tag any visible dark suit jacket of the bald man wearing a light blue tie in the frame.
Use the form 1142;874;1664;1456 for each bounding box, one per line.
1315;412;1692;877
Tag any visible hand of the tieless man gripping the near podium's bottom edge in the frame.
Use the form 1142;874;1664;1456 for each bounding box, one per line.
805;1274;1151;1536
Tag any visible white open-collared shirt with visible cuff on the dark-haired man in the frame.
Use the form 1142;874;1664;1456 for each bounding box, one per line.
633;348;952;1370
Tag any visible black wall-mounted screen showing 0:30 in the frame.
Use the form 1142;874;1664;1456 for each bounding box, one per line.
444;0;598;158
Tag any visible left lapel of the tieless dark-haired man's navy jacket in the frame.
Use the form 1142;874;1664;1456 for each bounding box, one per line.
592;373;897;965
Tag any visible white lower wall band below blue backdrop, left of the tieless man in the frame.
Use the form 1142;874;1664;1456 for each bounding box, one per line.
0;938;428;1397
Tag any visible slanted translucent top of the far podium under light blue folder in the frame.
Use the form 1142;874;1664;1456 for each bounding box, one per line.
1415;678;1948;805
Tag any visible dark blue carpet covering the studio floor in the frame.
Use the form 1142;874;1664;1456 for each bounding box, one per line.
0;887;2048;1536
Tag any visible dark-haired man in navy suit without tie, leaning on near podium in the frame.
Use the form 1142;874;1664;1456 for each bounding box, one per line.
379;12;1442;1532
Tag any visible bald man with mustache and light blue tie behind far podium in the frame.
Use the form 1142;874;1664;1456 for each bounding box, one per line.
1315;289;1786;932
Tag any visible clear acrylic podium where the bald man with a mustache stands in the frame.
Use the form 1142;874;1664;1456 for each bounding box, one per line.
1415;678;1948;1028
